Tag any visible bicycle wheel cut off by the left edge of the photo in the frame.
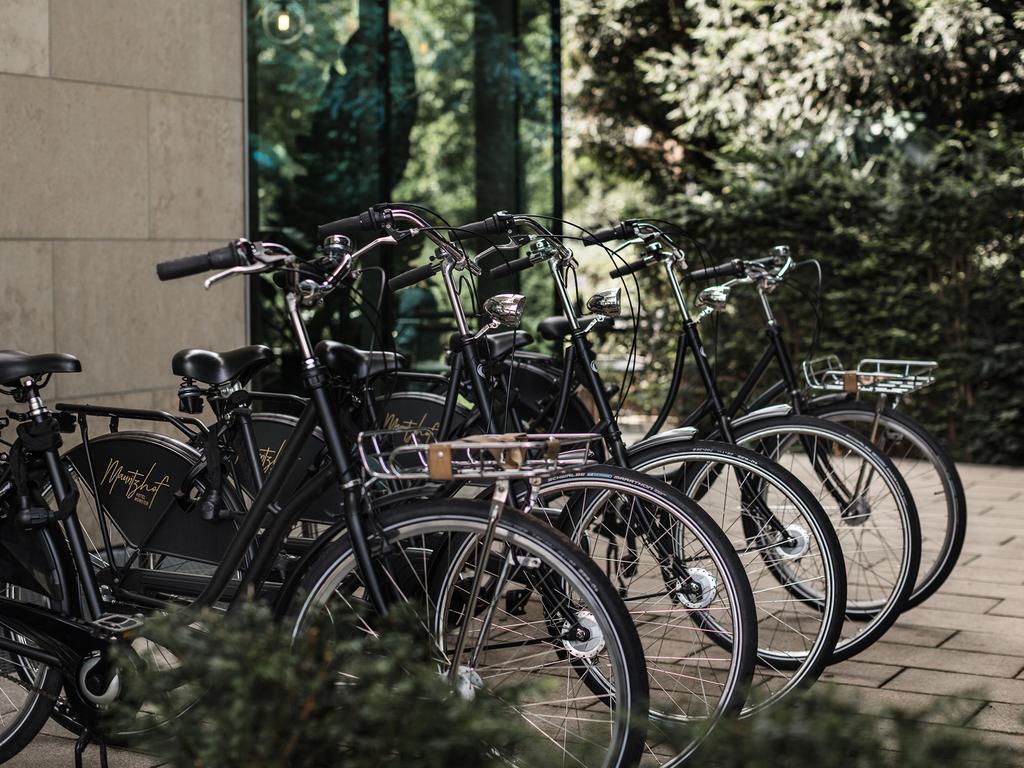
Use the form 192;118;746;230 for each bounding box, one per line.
0;519;67;763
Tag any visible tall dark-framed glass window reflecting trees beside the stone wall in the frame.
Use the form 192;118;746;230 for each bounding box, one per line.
248;0;561;388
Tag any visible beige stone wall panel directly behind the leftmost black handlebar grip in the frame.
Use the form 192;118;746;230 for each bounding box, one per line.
53;242;246;398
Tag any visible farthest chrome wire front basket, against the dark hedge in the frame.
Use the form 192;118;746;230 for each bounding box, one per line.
803;354;939;395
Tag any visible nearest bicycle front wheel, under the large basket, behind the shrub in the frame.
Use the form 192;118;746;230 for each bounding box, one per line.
293;500;647;768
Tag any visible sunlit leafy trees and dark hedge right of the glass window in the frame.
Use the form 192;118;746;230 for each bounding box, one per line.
565;0;1024;464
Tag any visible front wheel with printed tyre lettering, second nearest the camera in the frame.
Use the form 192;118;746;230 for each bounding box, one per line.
531;467;757;765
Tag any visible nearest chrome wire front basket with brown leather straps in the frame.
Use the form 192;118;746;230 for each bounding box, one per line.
358;429;601;481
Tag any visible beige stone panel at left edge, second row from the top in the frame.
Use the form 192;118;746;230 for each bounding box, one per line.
0;75;147;239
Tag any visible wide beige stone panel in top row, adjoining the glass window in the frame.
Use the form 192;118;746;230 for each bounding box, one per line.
50;0;243;99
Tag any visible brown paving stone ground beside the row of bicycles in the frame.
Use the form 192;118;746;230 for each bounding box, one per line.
8;465;1024;768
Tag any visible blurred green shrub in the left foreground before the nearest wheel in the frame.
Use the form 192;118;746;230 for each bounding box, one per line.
115;607;544;768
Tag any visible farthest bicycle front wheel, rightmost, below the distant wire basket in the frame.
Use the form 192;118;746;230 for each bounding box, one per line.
810;400;967;610
